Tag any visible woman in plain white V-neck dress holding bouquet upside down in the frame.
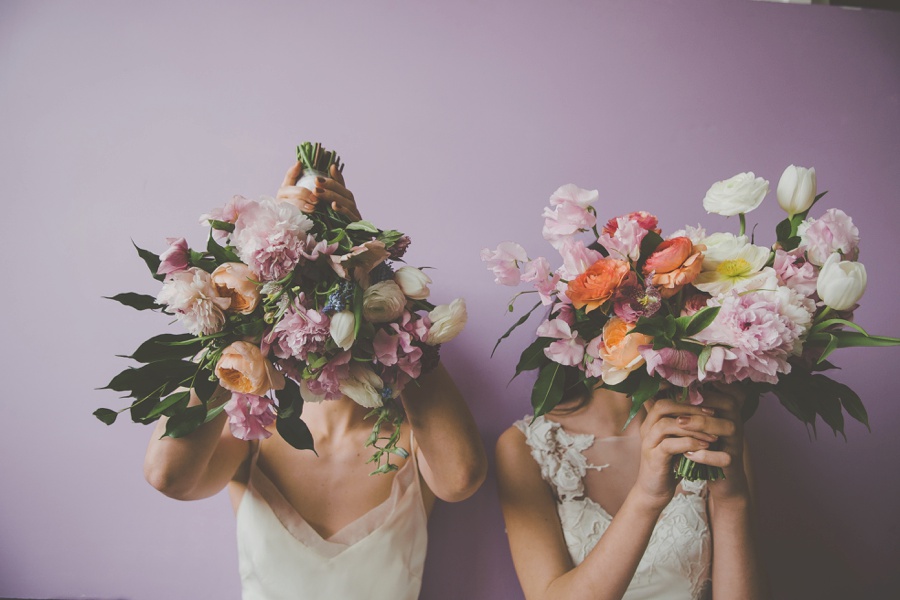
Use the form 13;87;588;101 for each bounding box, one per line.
144;162;486;600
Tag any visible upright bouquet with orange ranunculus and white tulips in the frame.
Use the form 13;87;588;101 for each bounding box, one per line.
481;165;900;480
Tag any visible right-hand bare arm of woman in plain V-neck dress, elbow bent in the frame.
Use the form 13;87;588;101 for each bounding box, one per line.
403;365;487;502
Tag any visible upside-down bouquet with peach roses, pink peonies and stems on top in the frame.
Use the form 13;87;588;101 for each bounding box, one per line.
101;142;466;473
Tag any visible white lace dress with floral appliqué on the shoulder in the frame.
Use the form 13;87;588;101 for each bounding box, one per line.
515;417;712;600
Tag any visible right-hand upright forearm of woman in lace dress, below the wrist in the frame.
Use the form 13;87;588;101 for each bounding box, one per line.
710;494;768;600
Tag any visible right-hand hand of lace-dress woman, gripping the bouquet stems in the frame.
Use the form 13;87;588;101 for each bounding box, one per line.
682;383;749;501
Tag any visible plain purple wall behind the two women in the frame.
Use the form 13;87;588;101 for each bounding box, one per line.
0;0;900;599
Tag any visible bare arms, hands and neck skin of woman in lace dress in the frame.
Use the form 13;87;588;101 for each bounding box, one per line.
497;387;768;600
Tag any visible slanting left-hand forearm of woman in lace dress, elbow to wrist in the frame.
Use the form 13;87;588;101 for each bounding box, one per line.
540;489;663;600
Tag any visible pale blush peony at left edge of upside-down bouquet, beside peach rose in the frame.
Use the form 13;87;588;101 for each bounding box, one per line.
156;267;231;335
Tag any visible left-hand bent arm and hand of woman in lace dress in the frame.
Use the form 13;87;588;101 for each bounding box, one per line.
497;401;724;600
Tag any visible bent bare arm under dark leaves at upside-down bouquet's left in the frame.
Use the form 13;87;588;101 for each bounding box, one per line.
144;388;250;500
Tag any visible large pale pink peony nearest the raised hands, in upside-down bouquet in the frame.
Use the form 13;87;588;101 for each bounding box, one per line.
231;198;313;281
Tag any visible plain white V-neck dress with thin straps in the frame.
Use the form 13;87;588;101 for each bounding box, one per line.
237;442;428;600
